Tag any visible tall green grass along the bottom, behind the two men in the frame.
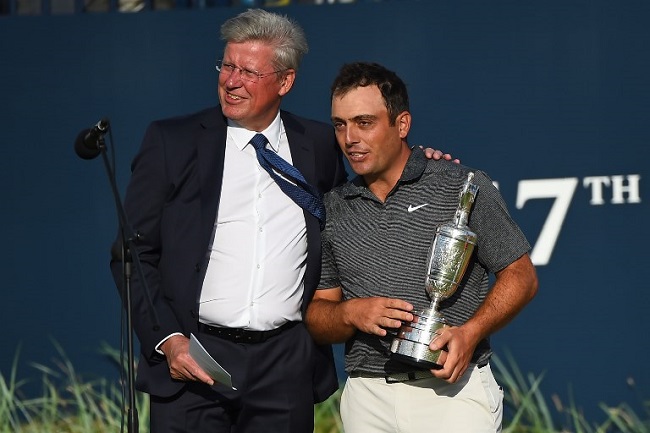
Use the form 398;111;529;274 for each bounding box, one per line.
0;344;650;433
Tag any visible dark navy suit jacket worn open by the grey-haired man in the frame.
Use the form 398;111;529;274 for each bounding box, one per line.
111;107;346;401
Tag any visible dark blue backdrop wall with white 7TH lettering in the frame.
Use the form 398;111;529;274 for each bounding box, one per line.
0;0;650;424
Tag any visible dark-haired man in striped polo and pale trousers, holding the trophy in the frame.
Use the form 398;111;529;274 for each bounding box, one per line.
306;63;537;433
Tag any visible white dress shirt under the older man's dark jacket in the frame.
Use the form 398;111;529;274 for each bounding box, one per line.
199;113;307;331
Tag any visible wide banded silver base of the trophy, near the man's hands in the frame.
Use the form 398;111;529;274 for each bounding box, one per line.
390;309;446;369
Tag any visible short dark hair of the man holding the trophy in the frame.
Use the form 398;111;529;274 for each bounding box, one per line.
331;62;410;125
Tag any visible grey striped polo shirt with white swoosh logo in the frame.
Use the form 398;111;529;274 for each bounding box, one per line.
319;148;530;373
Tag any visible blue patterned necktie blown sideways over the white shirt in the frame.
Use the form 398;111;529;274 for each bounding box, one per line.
250;134;325;229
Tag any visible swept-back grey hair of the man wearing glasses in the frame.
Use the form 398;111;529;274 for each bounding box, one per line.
221;9;309;70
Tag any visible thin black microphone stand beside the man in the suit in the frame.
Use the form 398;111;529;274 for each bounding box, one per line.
96;135;160;433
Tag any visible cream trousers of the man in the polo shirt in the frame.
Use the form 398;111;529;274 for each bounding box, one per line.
341;364;503;433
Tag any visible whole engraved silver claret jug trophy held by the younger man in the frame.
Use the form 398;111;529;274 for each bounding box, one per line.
390;172;478;369
